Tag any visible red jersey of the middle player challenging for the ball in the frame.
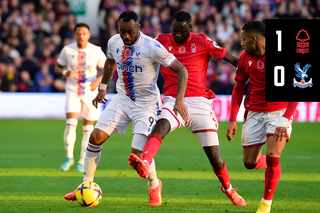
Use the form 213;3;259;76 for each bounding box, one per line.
156;32;227;99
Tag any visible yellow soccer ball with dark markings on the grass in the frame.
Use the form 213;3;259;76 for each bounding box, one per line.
76;181;102;207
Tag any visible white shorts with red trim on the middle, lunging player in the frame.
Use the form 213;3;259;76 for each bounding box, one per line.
161;96;219;146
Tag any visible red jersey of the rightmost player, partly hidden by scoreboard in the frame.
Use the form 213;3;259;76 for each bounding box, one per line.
229;51;288;121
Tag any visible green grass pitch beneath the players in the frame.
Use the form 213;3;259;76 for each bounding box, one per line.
0;120;320;213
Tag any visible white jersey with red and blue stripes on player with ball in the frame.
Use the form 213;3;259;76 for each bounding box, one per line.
108;32;176;105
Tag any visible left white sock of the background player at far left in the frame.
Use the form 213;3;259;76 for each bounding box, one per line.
63;118;78;158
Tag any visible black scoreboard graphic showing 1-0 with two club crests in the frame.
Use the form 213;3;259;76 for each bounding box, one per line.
265;19;320;102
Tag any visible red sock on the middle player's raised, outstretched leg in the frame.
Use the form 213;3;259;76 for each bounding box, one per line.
142;134;162;164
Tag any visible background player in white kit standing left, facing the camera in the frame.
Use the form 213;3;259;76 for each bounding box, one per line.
55;23;106;172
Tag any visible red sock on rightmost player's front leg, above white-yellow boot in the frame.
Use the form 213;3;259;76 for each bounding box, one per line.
263;157;281;200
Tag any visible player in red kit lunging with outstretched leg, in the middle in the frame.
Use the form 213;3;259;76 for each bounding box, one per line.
129;11;246;206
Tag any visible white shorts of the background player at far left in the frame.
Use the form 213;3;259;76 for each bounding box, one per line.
66;90;100;121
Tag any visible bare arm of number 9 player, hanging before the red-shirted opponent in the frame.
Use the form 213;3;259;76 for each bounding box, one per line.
169;60;189;123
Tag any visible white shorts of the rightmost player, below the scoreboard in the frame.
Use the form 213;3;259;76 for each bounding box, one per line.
241;109;293;148
